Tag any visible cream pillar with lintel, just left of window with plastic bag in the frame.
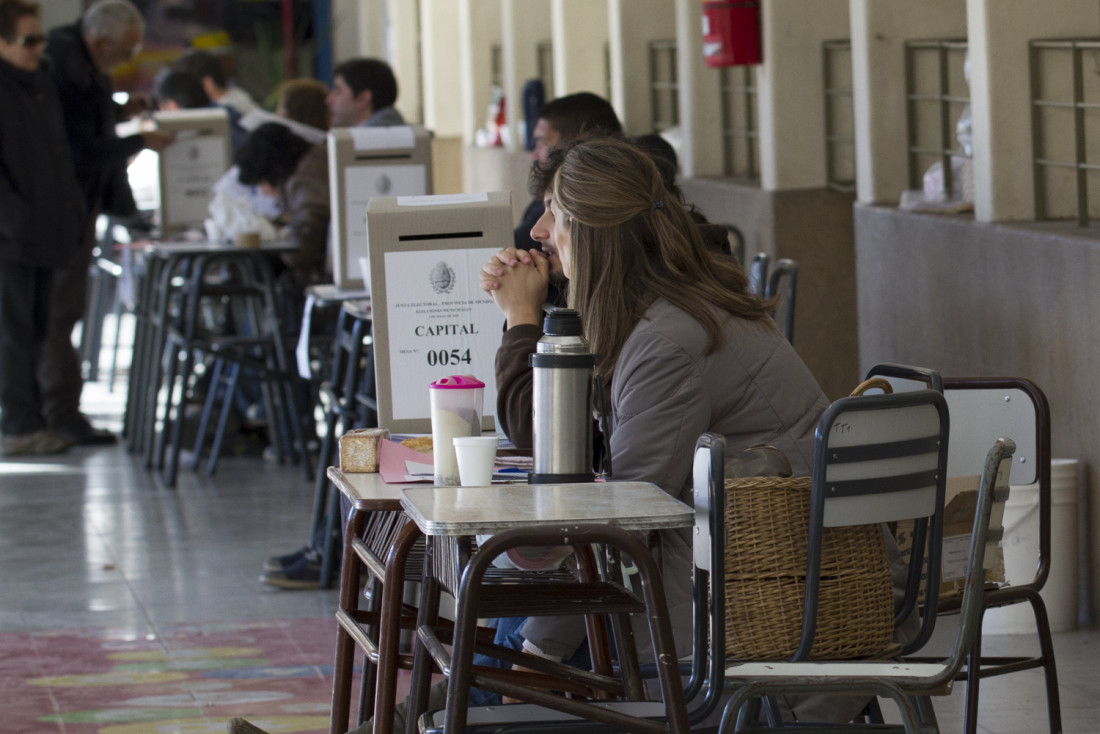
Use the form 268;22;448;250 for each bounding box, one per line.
844;0;968;205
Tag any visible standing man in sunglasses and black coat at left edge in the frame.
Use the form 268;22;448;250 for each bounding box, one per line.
0;0;86;457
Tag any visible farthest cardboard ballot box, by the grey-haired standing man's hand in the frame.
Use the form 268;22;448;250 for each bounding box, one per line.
154;108;232;232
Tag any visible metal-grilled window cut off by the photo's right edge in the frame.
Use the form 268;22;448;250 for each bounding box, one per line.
1030;39;1100;227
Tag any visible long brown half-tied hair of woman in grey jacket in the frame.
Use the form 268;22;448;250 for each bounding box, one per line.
553;138;769;380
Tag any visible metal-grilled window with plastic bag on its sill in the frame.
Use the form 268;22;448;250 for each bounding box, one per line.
905;40;970;198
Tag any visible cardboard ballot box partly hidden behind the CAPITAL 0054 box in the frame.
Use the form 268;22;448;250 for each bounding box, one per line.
328;125;431;291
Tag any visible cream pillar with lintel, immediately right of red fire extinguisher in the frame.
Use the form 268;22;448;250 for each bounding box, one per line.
757;0;850;190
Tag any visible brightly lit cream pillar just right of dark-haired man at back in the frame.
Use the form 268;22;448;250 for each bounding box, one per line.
420;0;465;138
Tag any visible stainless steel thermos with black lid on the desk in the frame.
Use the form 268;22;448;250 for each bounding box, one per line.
529;308;596;484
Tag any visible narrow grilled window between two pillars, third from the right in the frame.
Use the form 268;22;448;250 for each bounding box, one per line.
822;41;856;191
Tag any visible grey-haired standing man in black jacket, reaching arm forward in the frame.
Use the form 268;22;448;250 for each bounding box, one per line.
39;0;172;445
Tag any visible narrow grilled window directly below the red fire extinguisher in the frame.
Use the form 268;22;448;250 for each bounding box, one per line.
719;66;760;182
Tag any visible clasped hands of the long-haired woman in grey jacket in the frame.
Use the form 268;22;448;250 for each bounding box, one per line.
479;248;550;329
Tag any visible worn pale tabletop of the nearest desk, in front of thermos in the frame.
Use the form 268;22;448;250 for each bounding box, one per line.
392;482;694;535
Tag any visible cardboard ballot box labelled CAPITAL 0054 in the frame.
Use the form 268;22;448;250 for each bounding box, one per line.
366;191;513;434
